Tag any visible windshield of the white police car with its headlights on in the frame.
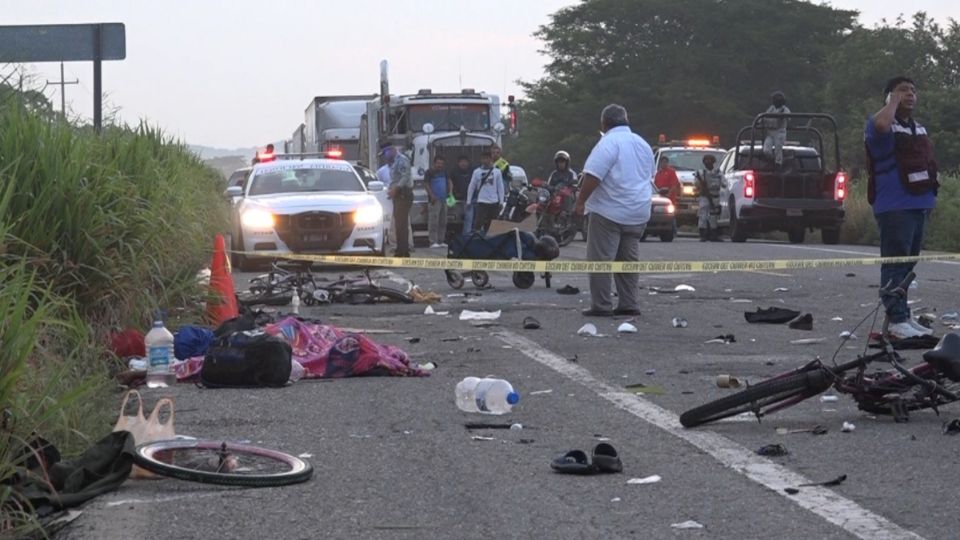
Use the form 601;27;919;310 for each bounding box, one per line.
248;167;366;196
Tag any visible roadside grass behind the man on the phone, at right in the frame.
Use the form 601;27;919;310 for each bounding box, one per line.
841;174;960;253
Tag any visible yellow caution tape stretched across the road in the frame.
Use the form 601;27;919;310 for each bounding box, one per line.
244;251;960;274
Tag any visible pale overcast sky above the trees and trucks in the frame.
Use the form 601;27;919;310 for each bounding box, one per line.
0;0;960;147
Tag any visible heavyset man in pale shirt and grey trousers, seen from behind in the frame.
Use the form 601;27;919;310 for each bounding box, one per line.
576;104;653;317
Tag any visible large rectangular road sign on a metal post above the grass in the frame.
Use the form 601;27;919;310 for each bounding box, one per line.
0;23;127;133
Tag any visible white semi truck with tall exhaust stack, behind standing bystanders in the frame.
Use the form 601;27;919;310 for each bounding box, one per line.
359;61;505;234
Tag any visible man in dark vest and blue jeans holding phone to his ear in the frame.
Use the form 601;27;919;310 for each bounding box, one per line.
864;76;940;339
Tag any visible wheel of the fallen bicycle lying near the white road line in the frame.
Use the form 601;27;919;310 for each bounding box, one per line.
680;370;830;427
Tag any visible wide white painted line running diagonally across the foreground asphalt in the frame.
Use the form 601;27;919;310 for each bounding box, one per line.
494;331;922;540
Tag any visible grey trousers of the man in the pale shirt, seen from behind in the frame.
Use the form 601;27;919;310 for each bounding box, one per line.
587;213;646;311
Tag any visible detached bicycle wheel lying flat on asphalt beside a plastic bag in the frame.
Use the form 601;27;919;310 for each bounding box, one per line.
134;439;313;487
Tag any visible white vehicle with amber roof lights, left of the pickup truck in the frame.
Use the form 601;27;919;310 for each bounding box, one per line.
653;139;726;226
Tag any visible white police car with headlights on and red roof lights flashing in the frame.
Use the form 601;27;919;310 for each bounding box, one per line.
227;154;385;270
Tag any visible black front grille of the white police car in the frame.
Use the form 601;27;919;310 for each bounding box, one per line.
275;211;354;251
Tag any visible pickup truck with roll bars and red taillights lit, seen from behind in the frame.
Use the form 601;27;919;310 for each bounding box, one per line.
718;113;847;244
